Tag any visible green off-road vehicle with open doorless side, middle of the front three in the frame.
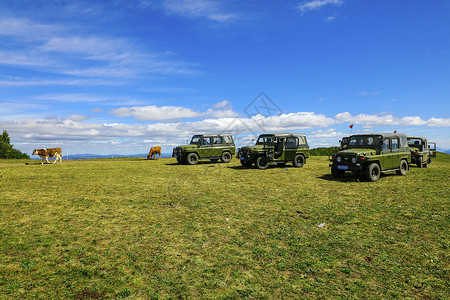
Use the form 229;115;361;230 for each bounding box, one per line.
237;133;309;170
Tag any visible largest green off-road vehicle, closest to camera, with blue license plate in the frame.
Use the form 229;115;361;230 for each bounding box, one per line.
330;133;411;181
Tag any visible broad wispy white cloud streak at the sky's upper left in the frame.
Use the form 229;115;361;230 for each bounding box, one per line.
0;18;198;80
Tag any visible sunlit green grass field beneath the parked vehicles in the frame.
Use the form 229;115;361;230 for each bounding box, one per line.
0;154;450;299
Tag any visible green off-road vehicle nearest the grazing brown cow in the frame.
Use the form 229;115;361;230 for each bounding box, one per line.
172;134;236;165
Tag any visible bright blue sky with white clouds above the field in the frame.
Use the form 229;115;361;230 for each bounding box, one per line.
0;0;450;155
